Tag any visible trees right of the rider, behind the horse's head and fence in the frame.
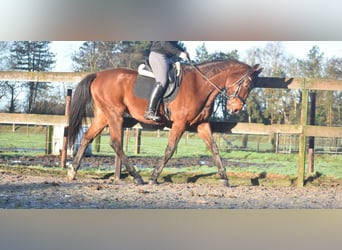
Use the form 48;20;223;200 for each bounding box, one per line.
195;42;342;126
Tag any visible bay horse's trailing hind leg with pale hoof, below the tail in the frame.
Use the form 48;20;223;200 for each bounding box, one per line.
67;119;107;181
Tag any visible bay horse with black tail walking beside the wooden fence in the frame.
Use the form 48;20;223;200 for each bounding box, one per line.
67;60;262;186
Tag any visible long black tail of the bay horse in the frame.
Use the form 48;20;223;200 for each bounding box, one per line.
68;73;96;147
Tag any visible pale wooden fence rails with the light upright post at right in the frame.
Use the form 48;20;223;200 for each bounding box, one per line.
0;71;342;186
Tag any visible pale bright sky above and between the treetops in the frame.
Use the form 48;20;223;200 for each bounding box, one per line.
51;41;342;72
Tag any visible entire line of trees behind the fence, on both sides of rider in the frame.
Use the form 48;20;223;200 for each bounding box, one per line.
0;41;342;126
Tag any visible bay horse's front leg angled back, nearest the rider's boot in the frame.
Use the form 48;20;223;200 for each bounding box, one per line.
148;124;185;184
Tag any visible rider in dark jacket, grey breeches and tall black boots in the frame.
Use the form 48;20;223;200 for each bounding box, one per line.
144;41;190;121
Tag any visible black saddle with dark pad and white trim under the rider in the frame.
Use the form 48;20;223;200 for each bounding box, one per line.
134;60;182;102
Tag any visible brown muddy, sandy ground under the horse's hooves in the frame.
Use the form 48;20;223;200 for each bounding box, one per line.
0;156;342;209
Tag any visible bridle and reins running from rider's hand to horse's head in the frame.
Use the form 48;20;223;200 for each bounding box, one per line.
190;62;253;105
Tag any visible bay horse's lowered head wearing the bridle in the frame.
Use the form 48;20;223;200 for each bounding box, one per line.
225;64;263;114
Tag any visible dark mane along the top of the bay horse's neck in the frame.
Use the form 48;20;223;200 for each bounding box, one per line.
184;59;249;77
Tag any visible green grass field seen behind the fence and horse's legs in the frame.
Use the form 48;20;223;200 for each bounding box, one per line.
0;125;342;179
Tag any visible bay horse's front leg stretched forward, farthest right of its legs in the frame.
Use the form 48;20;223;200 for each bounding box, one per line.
197;122;229;187
